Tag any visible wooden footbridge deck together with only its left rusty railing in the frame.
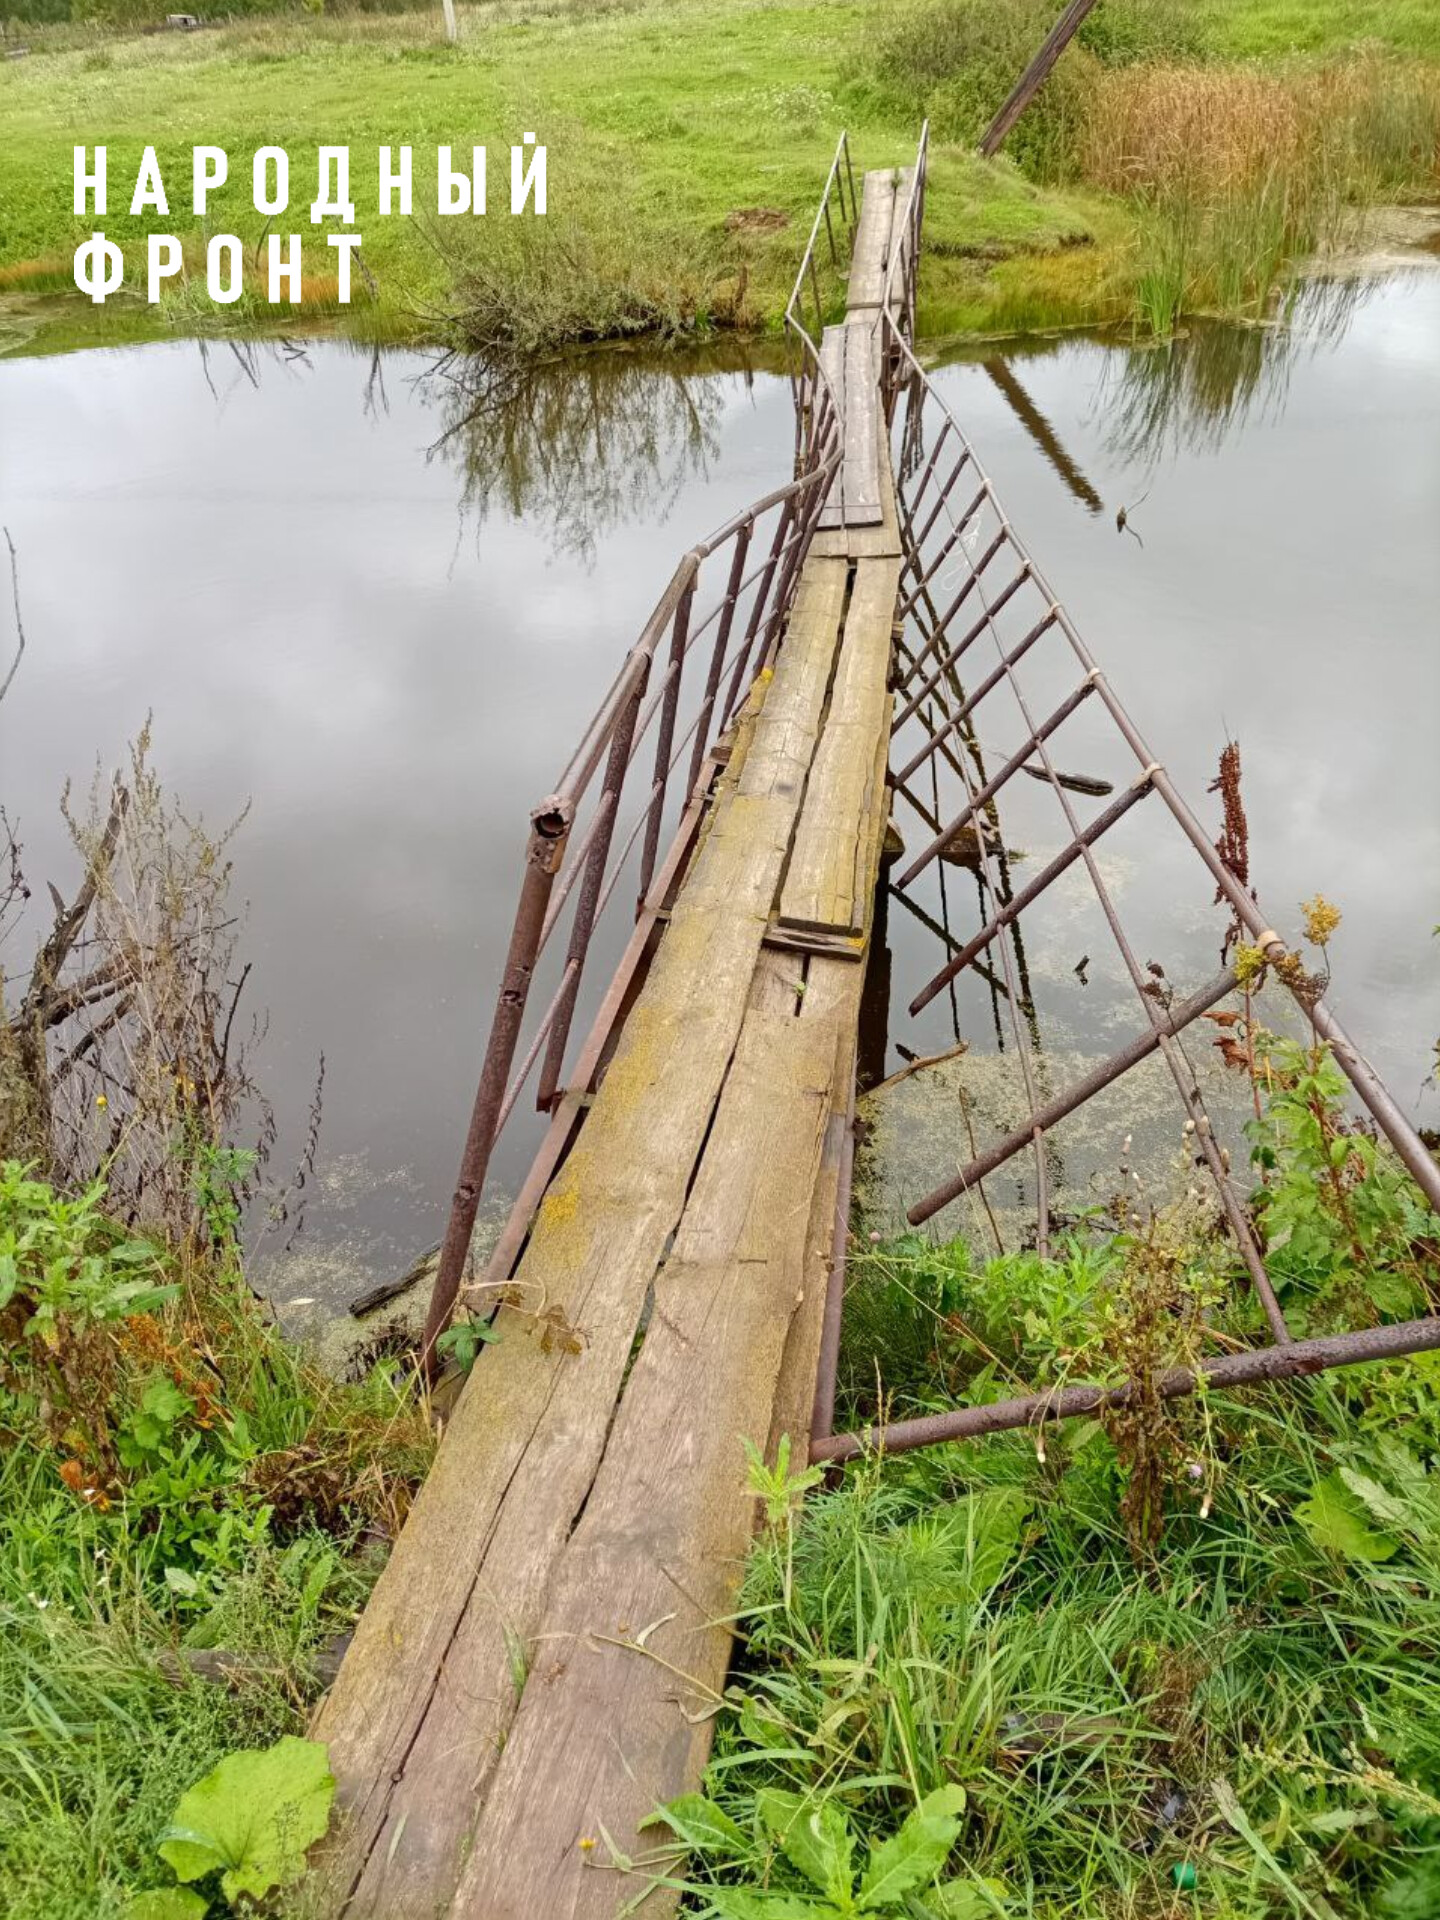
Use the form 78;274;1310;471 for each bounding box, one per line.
315;150;914;1920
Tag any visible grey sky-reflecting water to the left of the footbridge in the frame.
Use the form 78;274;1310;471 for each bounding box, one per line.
0;346;791;1298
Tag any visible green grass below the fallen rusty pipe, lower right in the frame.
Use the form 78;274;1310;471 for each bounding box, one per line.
689;1367;1440;1920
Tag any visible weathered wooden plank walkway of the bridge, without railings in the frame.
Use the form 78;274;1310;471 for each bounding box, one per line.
315;175;900;1920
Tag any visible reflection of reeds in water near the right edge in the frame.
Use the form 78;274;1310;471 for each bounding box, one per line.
1098;278;1375;465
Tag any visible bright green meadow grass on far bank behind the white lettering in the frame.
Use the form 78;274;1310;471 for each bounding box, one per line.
0;0;1091;357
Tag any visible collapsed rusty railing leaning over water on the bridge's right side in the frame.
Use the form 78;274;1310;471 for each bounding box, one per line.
810;120;1440;1461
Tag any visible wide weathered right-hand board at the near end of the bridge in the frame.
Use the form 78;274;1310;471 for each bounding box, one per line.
451;981;837;1920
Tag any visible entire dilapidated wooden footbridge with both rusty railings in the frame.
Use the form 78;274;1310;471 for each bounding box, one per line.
315;127;1440;1920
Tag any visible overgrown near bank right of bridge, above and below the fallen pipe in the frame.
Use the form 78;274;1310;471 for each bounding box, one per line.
664;1031;1440;1920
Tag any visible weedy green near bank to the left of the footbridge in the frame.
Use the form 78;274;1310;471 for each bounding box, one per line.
0;1162;430;1920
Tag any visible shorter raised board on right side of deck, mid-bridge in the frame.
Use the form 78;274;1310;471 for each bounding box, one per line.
778;559;900;933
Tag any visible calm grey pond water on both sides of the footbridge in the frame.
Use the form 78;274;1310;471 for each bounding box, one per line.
0;269;1440;1302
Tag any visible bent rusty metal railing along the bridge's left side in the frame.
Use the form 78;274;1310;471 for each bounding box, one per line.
422;134;856;1369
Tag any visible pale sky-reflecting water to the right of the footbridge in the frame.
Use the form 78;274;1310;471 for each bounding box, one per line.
893;269;1440;1123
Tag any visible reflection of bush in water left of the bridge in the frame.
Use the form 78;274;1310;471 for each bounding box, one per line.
419;353;724;559
